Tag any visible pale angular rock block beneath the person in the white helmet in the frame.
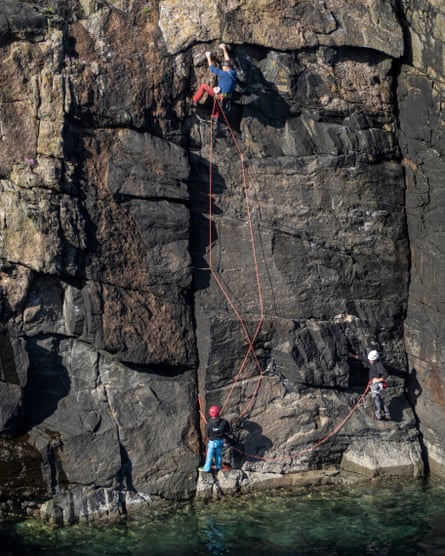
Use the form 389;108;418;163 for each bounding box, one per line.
341;438;425;478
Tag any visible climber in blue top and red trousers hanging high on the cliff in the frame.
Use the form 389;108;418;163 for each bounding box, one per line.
192;43;236;126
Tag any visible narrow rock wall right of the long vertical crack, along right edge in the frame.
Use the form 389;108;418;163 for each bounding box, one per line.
397;1;445;474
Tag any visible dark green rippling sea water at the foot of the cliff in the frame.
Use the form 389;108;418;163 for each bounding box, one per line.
0;479;445;556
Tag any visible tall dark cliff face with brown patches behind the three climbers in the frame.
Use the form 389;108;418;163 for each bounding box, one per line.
0;0;443;522
